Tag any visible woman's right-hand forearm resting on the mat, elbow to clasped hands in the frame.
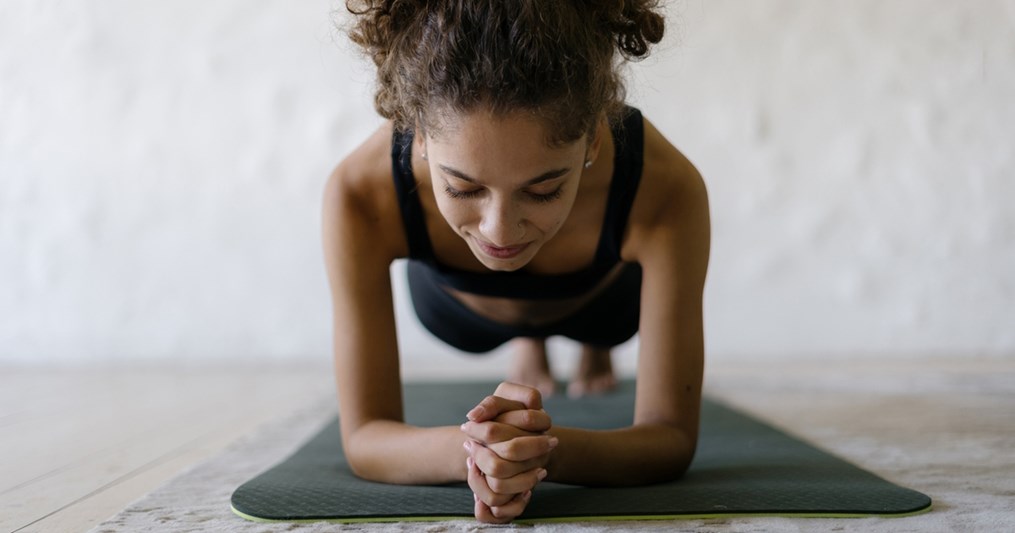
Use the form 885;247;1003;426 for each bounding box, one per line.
547;424;696;486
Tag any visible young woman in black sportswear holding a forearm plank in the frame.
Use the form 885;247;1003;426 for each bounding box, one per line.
324;0;709;522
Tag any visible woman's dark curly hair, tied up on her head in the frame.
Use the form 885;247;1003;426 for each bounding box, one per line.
346;0;664;144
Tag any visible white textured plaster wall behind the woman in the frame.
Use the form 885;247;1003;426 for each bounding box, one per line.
0;0;1015;362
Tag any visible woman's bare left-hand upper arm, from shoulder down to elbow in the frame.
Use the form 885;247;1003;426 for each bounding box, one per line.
322;131;404;439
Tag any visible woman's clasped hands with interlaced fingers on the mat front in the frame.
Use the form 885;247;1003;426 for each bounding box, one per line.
462;383;557;524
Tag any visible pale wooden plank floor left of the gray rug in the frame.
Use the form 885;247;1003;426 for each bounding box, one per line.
0;365;334;533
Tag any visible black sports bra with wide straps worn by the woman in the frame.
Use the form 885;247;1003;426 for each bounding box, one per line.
391;107;645;299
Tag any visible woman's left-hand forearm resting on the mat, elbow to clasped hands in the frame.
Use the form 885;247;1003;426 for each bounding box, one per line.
344;420;466;484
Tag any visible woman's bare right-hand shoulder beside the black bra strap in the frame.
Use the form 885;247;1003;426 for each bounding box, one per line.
623;119;711;272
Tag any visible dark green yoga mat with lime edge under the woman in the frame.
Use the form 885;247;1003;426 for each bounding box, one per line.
232;383;931;522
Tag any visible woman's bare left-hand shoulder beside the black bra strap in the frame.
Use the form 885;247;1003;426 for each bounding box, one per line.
322;122;407;259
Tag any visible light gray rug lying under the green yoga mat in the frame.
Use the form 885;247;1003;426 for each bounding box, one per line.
92;373;1015;533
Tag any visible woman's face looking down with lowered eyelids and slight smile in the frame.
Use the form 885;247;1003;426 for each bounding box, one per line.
422;111;598;271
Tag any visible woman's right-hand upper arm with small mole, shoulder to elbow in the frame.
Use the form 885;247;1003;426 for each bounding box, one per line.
625;122;711;440
